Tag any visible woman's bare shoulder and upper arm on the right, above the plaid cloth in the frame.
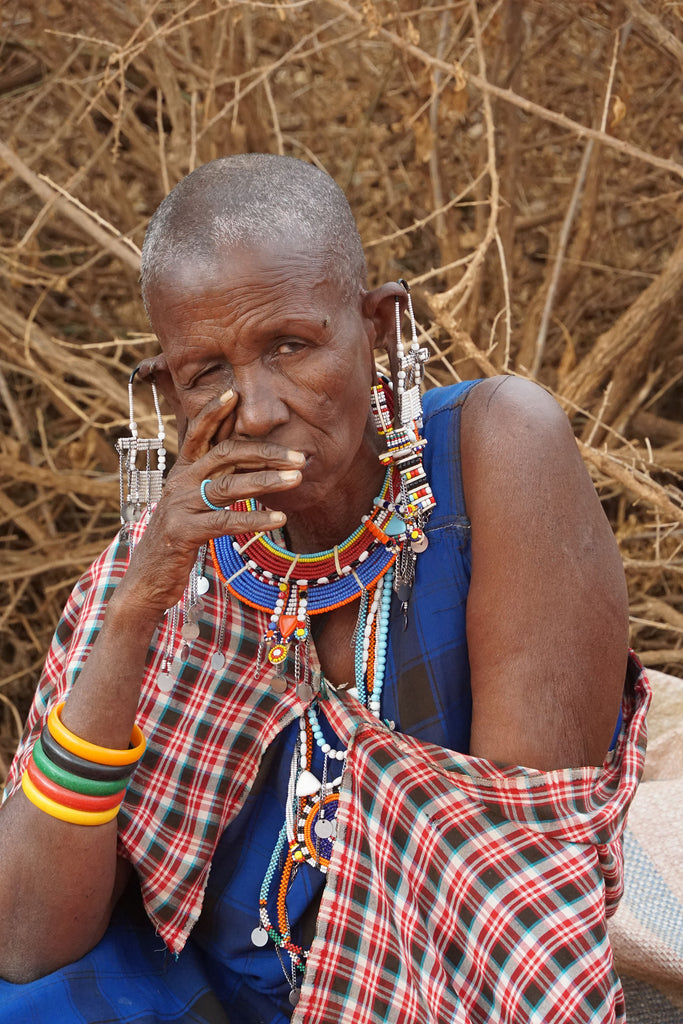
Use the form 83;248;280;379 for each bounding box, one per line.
462;378;628;767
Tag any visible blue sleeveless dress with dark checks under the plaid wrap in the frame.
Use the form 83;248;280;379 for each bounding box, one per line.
0;381;475;1024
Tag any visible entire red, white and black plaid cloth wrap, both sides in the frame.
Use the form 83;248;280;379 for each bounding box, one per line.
6;505;649;1024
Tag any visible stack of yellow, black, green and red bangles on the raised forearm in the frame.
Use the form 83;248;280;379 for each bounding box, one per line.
22;703;145;825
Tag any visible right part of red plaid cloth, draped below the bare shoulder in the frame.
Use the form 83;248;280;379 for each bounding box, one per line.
293;673;649;1024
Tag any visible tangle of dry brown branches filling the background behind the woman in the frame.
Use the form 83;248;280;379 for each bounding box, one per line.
0;0;683;774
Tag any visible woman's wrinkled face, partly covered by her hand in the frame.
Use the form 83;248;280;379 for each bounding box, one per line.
148;239;385;511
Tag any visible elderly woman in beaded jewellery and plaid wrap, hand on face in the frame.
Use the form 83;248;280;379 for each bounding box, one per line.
0;156;646;1024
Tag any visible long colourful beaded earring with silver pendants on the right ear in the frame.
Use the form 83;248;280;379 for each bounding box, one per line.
372;278;436;616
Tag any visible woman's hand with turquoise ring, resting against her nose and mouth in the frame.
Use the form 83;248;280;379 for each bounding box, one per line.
117;391;305;624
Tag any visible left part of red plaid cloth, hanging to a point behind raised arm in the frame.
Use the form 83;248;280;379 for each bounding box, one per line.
5;521;311;953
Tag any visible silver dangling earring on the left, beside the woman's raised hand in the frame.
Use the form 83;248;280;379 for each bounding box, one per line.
116;367;166;544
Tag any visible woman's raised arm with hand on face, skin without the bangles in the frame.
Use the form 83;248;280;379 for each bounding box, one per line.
0;395;304;983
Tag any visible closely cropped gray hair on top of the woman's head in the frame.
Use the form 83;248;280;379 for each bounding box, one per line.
140;153;367;306
